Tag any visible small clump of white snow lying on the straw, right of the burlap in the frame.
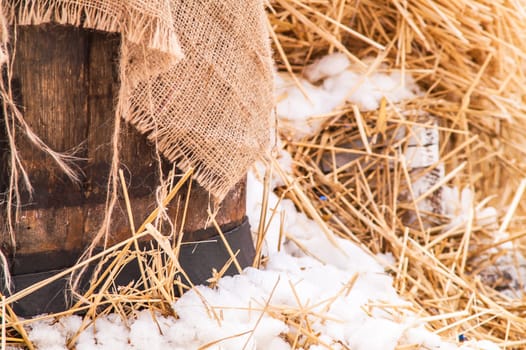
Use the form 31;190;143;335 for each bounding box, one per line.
276;53;420;138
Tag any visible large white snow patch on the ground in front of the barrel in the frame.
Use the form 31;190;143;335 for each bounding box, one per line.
24;167;502;350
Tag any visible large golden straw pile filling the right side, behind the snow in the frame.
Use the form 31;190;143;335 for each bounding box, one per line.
269;0;526;347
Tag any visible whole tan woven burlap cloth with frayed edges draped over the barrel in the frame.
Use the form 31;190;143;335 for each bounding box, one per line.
0;0;273;199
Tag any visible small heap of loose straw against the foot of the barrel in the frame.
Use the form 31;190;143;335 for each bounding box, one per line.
0;170;200;349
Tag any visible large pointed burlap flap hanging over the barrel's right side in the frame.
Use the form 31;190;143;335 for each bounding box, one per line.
119;0;274;203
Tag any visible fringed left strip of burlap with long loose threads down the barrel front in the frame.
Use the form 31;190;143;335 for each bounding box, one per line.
0;0;188;286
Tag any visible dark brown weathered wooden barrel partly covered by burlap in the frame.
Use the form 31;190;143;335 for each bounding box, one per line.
0;25;253;314
